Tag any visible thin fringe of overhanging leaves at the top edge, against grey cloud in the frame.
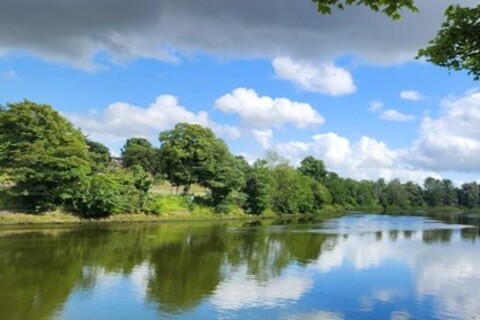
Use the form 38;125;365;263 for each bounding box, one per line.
312;0;418;20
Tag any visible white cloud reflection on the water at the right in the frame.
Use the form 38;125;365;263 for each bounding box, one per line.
314;215;480;319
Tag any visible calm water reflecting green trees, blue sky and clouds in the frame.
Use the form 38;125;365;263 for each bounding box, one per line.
0;214;480;319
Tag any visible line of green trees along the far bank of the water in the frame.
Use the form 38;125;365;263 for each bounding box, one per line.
0;101;480;217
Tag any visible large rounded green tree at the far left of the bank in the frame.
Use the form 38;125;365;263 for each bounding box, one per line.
0;100;90;211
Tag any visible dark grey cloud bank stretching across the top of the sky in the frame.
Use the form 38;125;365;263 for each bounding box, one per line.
0;0;477;68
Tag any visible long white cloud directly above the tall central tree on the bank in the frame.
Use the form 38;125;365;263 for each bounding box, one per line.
69;95;240;140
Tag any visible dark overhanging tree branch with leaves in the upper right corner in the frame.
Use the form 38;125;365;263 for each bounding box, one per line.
417;5;480;80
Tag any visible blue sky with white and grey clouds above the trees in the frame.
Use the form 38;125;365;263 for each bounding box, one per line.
0;0;480;184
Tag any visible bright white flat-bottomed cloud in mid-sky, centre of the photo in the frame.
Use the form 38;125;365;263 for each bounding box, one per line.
215;88;325;129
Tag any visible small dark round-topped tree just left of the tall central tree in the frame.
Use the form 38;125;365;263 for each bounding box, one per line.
122;138;160;176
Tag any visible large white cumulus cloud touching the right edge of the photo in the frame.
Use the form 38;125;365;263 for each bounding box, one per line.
409;91;480;172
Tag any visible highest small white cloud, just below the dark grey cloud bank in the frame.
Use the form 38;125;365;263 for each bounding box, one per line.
272;57;357;96
